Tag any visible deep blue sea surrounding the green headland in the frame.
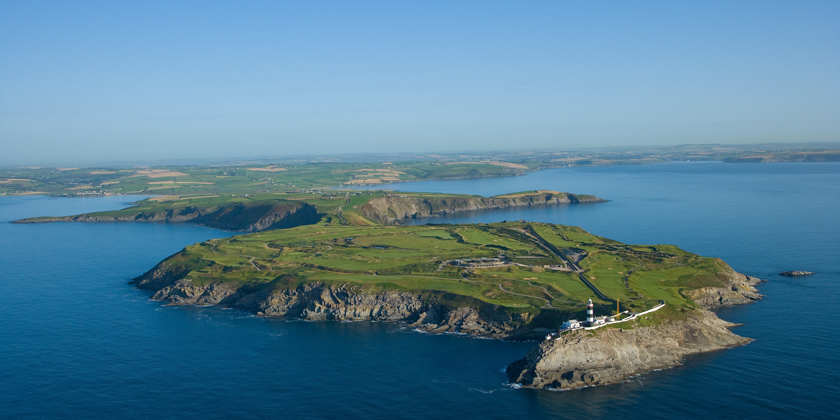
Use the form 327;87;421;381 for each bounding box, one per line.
0;162;840;419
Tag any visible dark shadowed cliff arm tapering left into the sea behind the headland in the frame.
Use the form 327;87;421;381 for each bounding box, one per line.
14;200;321;232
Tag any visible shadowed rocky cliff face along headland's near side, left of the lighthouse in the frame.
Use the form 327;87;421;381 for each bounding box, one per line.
132;266;531;338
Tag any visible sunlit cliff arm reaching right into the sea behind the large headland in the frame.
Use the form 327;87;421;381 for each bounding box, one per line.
358;193;606;224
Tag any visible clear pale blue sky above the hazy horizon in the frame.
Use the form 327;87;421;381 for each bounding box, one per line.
0;0;840;165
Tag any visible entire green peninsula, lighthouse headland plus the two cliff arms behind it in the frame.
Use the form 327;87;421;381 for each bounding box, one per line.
9;175;760;389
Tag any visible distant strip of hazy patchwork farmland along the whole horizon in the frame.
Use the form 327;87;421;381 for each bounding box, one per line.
0;143;840;197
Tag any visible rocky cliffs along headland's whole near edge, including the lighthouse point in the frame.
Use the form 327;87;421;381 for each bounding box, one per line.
131;256;762;389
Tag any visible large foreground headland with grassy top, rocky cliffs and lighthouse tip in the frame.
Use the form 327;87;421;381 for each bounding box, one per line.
132;217;761;389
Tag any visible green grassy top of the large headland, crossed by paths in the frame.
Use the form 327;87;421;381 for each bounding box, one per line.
146;222;731;314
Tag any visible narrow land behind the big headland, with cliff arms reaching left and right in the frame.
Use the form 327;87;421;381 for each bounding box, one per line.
14;190;606;232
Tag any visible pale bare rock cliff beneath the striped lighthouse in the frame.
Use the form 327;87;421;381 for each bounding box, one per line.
506;272;761;389
